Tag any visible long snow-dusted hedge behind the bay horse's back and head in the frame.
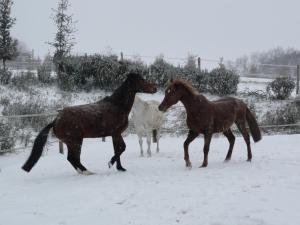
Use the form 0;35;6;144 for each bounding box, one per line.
58;55;147;90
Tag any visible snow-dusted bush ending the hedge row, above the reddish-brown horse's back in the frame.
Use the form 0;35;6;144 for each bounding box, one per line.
208;65;239;96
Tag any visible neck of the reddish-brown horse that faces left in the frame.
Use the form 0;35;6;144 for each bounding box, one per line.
180;89;209;113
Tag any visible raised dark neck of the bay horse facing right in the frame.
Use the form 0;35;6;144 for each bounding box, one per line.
109;81;136;114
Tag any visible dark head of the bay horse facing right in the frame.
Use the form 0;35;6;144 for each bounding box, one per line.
127;73;157;94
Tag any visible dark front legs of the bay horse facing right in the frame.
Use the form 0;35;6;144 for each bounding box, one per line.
108;134;126;171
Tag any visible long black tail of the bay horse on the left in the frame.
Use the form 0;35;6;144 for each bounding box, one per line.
22;120;55;172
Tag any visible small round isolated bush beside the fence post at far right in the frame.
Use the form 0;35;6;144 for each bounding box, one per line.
266;77;296;100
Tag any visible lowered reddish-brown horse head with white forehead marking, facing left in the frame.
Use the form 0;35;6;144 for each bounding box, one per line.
158;79;182;112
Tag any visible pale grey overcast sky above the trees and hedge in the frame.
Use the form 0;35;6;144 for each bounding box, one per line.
13;0;300;65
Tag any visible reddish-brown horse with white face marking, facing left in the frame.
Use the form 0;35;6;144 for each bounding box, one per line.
159;80;261;167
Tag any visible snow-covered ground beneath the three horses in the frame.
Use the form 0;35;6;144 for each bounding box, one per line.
0;135;300;225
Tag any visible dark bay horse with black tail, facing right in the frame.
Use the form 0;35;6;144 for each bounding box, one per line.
22;73;156;175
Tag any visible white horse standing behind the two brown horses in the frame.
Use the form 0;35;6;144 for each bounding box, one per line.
132;96;164;157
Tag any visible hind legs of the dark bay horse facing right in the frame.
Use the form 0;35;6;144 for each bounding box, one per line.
67;139;92;175
